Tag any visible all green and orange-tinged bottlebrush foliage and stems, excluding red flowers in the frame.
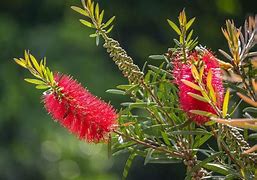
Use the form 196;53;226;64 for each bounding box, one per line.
12;0;257;179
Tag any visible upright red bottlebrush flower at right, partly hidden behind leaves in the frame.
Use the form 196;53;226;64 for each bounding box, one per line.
173;51;224;124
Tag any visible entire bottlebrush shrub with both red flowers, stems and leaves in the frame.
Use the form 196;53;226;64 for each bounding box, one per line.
15;0;257;180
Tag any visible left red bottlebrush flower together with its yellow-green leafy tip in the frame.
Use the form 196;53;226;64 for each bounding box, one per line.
15;51;118;143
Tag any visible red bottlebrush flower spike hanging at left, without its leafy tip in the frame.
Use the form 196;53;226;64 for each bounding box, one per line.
43;74;117;143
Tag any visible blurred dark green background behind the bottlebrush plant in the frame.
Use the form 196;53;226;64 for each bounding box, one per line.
0;0;257;180
